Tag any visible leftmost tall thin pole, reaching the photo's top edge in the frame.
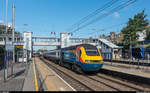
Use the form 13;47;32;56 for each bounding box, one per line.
4;0;8;81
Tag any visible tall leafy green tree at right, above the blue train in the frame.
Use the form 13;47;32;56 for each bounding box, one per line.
122;10;149;48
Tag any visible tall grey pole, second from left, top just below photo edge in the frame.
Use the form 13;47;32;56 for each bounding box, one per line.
11;4;15;75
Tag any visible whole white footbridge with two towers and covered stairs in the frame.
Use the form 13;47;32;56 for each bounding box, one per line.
0;32;120;61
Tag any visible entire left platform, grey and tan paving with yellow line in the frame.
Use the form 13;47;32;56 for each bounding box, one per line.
0;58;75;91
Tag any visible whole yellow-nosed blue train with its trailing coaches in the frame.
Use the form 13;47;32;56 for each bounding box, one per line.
43;44;103;73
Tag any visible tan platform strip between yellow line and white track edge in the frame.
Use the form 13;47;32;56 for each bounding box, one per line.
35;58;75;91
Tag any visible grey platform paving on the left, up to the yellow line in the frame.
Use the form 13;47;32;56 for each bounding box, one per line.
0;58;44;91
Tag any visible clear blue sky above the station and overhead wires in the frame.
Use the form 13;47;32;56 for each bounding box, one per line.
0;0;150;50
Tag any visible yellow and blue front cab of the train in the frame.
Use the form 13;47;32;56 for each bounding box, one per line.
77;47;103;72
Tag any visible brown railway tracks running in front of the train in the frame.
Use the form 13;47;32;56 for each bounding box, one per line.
40;58;150;91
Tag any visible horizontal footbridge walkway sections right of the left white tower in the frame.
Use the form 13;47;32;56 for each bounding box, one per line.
32;36;94;46
